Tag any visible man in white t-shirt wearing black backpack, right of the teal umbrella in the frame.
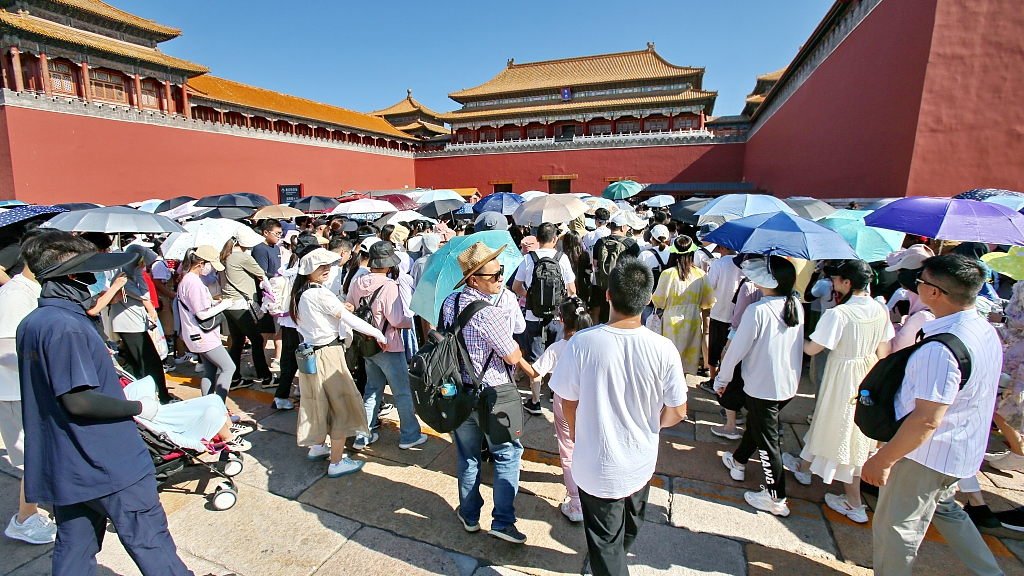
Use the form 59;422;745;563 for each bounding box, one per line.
512;222;575;414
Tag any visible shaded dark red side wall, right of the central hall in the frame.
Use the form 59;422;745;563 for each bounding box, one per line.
744;0;937;198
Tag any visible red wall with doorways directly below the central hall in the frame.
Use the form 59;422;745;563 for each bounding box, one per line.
416;143;744;194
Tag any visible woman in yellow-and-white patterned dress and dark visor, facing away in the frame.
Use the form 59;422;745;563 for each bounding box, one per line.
653;236;715;374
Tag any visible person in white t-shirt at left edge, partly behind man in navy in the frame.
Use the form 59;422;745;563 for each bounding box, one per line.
0;231;57;544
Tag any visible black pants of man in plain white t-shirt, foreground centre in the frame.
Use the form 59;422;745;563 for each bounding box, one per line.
580;483;650;576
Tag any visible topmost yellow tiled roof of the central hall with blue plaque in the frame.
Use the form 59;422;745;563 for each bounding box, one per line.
449;44;703;100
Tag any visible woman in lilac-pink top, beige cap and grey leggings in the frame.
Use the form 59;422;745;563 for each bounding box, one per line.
177;246;236;400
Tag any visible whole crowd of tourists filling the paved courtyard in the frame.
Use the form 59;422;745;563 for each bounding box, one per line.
0;192;1024;575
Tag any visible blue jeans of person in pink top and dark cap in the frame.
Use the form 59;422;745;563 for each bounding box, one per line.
362;352;420;444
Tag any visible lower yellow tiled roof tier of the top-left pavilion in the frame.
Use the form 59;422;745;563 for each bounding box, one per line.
0;10;210;74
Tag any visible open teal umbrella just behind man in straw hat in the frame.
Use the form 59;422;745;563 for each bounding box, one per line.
411;231;522;325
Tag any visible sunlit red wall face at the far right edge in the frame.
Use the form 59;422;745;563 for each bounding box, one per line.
907;0;1024;196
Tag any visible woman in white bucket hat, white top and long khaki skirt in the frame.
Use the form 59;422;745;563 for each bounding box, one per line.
289;248;387;478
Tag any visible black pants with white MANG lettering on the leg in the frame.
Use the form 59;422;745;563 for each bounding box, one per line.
732;397;790;498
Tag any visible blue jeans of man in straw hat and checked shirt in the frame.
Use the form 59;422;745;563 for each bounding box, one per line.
454;412;522;530
